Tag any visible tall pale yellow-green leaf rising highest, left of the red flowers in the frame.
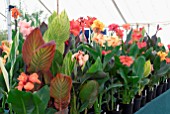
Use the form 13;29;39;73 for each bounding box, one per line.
44;11;70;54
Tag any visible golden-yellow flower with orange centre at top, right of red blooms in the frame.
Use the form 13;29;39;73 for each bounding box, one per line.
91;19;104;33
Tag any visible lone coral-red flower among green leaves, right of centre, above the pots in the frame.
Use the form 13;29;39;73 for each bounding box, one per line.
119;56;134;67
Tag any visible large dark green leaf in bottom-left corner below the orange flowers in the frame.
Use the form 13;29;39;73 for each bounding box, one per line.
8;89;45;114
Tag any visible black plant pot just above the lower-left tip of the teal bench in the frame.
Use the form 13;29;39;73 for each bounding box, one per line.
133;96;142;112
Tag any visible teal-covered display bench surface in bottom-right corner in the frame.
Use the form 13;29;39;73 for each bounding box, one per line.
135;89;170;114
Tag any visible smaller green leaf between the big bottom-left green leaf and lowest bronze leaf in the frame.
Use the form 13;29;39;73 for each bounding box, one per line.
34;85;50;109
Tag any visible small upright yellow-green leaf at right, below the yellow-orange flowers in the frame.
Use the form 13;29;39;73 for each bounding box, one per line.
143;60;152;77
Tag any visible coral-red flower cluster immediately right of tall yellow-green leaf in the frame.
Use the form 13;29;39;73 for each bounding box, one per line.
70;19;80;36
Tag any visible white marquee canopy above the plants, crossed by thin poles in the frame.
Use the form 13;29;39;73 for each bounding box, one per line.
0;0;170;44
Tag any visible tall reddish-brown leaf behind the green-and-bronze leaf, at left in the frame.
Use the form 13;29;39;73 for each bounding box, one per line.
22;28;45;65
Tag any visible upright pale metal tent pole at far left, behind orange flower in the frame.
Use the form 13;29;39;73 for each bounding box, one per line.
6;0;12;41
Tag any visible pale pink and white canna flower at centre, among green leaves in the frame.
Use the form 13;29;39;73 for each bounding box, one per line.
72;50;89;66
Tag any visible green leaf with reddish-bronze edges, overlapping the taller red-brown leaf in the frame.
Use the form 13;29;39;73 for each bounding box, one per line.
28;41;55;72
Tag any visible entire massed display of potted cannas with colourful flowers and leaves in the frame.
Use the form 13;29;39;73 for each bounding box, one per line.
0;8;170;114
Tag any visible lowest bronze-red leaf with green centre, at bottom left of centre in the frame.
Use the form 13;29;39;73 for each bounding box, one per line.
50;74;72;111
